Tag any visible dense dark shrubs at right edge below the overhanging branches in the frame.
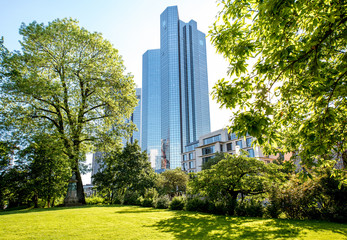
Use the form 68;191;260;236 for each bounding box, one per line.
269;161;347;222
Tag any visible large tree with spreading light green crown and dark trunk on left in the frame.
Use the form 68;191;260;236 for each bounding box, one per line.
0;19;137;203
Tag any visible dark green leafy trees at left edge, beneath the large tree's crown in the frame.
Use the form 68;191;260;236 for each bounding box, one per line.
0;135;71;207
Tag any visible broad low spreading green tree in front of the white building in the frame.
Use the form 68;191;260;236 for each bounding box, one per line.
189;154;278;206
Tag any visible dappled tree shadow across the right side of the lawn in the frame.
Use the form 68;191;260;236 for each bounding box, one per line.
152;212;347;240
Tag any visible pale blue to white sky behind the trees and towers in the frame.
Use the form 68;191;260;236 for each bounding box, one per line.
0;0;235;183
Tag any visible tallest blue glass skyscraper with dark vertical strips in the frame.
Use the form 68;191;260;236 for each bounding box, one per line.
143;6;210;169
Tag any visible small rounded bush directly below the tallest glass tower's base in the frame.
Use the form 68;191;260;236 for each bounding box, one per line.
156;168;189;197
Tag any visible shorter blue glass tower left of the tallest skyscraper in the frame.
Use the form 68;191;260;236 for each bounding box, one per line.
141;49;161;170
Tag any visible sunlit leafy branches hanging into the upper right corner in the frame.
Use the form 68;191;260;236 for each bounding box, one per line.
210;0;347;164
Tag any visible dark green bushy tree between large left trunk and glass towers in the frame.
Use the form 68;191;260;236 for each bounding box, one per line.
93;141;156;204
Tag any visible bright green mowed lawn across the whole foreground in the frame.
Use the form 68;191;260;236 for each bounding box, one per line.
0;206;347;240
